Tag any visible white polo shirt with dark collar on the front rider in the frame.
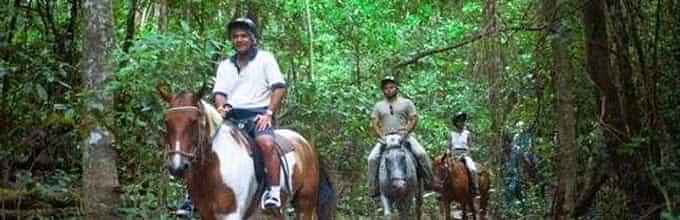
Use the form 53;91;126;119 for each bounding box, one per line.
213;50;285;109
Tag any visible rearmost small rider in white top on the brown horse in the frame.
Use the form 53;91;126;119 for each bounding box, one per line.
448;112;479;195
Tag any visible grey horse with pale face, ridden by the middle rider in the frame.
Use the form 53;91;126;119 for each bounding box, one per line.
378;134;423;219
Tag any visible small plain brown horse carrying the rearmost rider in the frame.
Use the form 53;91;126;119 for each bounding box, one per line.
432;153;490;220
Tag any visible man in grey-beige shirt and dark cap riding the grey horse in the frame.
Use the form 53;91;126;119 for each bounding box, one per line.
368;76;432;197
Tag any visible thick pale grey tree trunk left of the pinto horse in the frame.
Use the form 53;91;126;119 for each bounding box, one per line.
80;0;119;220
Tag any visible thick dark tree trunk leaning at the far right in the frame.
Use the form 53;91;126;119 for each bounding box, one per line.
583;0;663;219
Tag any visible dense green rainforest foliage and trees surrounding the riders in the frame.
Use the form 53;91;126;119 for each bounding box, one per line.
0;0;680;219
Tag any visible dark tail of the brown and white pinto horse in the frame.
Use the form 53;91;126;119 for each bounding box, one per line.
316;163;337;220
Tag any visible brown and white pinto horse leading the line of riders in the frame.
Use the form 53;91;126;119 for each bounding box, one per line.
158;87;335;220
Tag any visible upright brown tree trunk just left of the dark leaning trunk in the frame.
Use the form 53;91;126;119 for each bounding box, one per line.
542;0;579;220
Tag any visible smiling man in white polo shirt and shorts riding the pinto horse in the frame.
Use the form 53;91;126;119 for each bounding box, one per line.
213;18;286;209
